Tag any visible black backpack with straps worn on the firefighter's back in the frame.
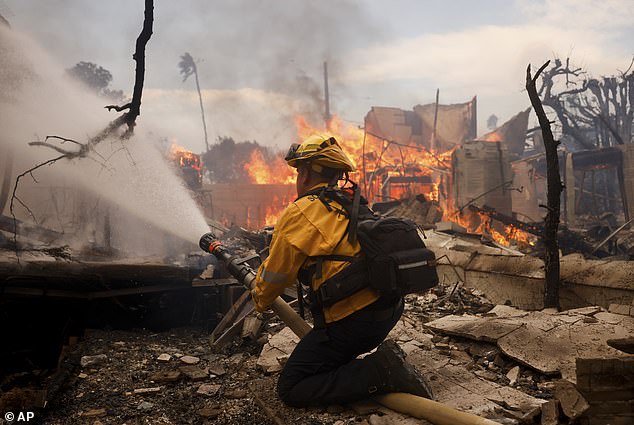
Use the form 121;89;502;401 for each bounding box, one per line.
300;184;438;307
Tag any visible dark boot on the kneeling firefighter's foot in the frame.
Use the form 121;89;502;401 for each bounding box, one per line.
366;340;434;400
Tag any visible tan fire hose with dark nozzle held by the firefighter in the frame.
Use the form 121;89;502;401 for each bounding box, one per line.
199;233;499;425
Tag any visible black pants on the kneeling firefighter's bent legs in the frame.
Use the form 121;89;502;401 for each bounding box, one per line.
277;302;403;407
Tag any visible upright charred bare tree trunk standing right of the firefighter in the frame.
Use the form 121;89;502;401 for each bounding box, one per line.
526;61;563;308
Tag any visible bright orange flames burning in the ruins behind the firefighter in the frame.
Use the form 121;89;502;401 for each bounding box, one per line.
239;116;536;246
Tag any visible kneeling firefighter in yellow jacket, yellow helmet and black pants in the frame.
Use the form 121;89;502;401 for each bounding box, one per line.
252;135;432;407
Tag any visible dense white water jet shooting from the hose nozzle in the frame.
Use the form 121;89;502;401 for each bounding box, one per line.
0;24;209;252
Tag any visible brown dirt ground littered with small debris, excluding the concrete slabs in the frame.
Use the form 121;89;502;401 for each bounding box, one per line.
19;288;549;425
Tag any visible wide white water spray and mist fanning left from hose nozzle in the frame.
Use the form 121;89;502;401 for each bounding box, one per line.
0;28;208;254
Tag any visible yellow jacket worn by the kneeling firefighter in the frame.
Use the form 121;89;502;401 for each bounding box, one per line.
251;184;379;323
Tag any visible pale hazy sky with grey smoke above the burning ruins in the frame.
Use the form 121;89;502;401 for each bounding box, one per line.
0;0;634;151
